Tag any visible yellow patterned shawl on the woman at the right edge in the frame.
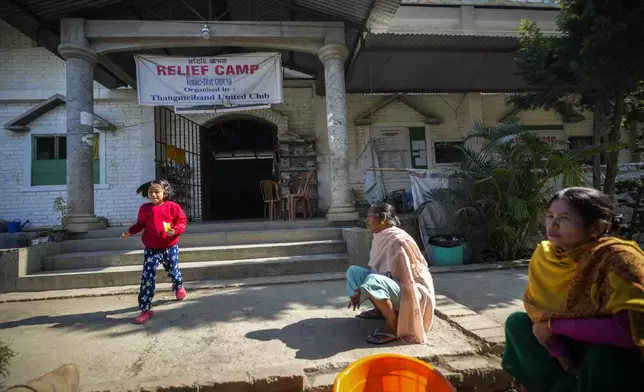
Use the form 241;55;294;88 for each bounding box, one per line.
523;237;644;347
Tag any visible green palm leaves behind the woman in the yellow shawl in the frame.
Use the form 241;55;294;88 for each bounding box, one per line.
421;123;611;260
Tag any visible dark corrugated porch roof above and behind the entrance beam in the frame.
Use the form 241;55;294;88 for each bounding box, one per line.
0;0;400;88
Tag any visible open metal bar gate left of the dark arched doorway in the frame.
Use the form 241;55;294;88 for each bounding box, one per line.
154;107;203;221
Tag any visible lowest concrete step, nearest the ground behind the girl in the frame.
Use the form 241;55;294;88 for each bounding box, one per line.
21;253;349;291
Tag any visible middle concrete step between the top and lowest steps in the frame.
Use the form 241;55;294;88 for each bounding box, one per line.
42;239;347;271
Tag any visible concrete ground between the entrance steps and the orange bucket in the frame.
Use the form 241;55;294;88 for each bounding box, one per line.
0;280;484;390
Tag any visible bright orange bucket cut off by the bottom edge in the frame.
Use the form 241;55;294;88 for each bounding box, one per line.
333;354;456;392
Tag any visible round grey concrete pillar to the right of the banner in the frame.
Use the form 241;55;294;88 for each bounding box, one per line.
318;44;358;223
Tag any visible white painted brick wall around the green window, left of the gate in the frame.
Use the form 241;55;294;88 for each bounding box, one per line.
0;21;154;226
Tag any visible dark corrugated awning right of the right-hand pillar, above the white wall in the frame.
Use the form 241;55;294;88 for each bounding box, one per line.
347;30;524;93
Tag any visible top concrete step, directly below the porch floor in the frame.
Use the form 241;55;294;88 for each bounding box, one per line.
62;227;342;253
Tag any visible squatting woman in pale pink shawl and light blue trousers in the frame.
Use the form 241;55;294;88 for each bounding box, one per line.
347;203;436;344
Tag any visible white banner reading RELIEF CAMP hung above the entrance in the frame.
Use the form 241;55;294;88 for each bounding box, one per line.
135;53;282;106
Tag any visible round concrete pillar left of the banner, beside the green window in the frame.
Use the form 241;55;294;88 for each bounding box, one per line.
58;41;104;233
